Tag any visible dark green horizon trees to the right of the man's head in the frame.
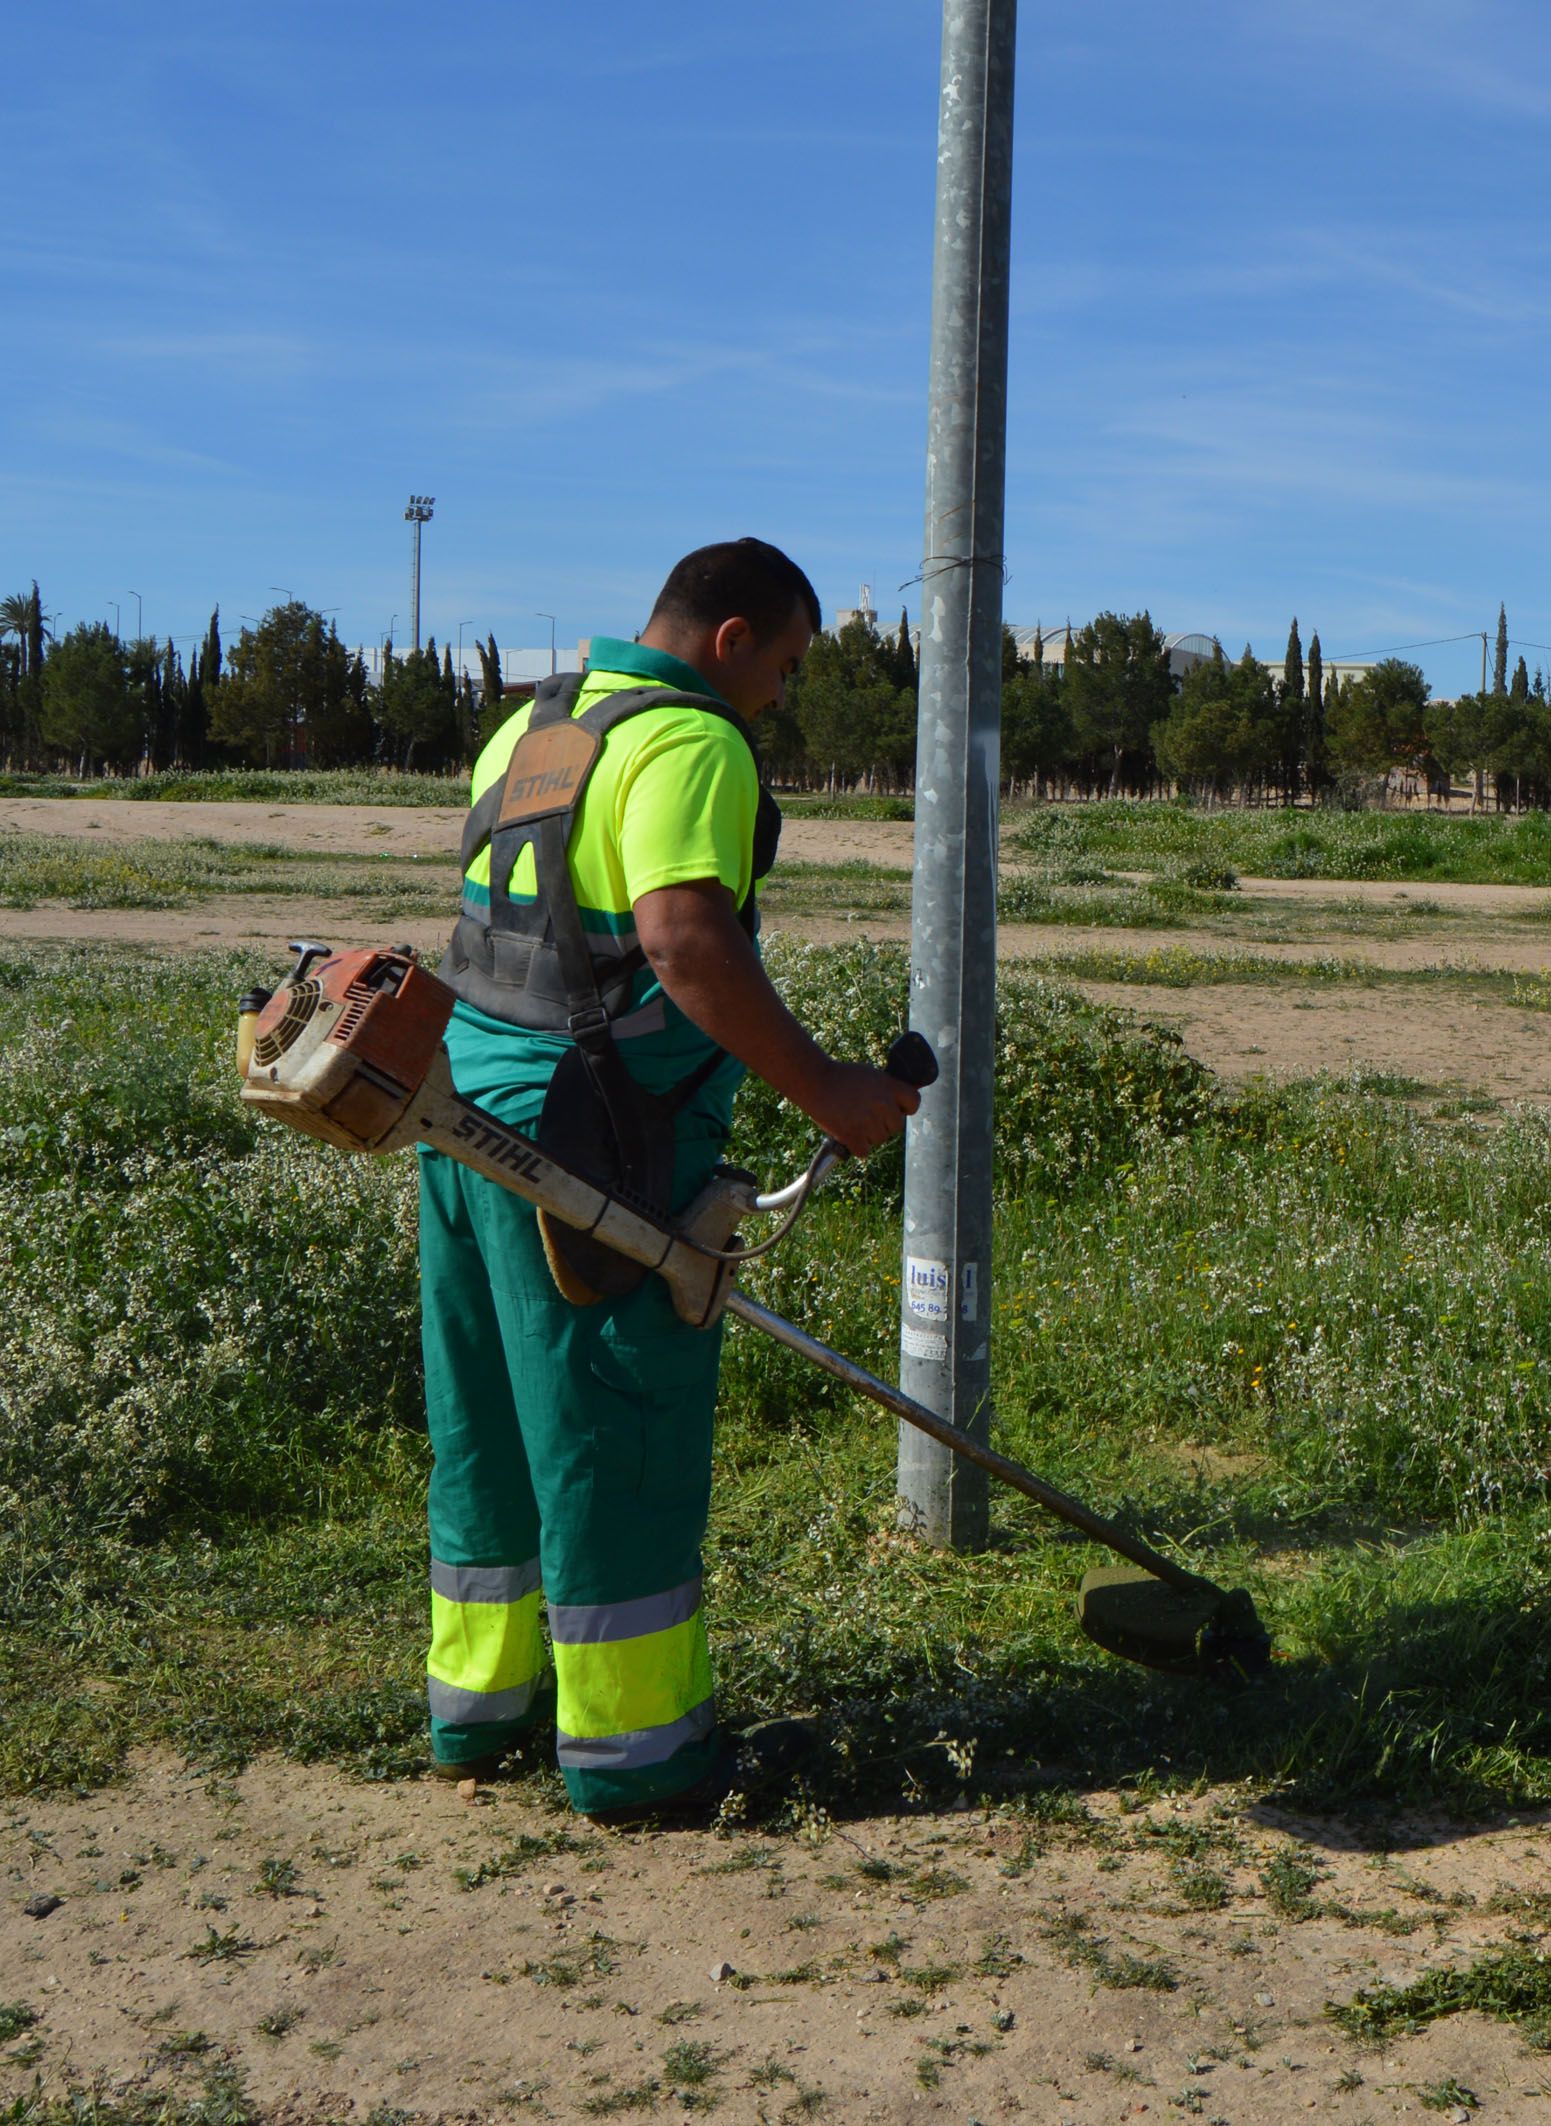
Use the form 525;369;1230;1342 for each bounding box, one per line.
761;610;1551;808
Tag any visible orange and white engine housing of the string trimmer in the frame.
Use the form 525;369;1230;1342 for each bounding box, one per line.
242;946;457;1152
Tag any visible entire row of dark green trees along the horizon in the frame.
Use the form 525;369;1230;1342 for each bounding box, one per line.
0;583;1551;808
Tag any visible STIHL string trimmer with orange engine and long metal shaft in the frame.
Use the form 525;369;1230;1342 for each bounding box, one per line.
238;944;1271;1680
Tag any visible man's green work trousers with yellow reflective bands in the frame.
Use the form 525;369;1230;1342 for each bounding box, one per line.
421;1142;720;1809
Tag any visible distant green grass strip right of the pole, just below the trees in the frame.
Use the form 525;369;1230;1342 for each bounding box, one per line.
1005;802;1551;887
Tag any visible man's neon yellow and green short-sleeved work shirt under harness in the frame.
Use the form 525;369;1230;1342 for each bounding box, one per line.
446;636;759;1131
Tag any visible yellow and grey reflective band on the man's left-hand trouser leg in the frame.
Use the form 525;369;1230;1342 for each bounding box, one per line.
425;1558;544;1726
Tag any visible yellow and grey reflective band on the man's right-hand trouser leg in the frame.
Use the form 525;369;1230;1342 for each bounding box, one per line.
550;1580;716;1790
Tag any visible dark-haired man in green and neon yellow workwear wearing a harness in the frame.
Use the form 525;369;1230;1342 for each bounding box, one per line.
421;538;918;1820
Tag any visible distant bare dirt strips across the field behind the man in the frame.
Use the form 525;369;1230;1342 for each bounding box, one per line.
0;797;1551;1101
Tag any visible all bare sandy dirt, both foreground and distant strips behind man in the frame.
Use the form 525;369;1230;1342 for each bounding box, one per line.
0;799;1551;2126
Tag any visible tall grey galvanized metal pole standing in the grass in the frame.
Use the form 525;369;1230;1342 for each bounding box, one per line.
899;0;1018;1550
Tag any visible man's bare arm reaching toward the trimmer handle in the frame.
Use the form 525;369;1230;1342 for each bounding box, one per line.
635;878;920;1157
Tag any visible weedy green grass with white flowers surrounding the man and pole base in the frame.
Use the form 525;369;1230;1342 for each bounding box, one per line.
0;940;1551;1819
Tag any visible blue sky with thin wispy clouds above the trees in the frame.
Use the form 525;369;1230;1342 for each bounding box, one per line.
0;0;1551;691
